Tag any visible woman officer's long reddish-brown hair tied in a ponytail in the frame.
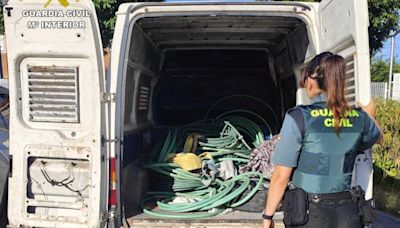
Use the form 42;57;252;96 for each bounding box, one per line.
299;52;350;134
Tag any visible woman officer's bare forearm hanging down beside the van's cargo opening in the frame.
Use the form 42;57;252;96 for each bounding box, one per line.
264;165;293;218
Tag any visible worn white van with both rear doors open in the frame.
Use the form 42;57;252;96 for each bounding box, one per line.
4;0;372;227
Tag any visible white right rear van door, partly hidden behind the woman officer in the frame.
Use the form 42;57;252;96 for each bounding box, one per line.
317;0;372;199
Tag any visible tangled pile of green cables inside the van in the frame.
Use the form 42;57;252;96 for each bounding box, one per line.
141;114;271;219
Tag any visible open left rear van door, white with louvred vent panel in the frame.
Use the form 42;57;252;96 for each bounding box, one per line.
4;0;108;227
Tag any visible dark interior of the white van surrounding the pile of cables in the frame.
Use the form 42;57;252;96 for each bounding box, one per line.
121;14;314;227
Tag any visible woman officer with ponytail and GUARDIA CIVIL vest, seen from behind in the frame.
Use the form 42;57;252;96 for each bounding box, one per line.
263;52;383;228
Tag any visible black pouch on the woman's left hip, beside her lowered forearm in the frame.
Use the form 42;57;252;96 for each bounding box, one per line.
283;188;308;226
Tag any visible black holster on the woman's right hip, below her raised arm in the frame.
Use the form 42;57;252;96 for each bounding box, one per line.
351;186;375;225
